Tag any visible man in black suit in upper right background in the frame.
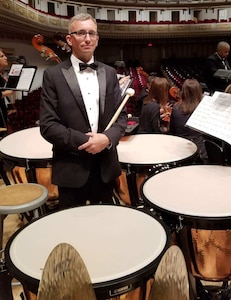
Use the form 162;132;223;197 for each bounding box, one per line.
204;41;230;94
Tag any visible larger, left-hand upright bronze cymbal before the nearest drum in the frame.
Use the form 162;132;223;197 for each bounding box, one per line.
37;243;96;300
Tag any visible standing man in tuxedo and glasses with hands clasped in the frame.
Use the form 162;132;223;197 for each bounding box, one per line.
40;14;127;209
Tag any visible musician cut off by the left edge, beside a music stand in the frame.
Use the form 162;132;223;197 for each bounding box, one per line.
0;49;14;137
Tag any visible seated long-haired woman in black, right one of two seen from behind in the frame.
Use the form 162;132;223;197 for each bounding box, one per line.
169;79;207;163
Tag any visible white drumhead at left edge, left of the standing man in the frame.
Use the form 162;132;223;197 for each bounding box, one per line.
0;127;52;159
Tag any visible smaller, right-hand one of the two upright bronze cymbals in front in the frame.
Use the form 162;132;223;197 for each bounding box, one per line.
149;245;189;300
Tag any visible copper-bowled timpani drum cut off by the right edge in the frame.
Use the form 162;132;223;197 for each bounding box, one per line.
142;165;231;281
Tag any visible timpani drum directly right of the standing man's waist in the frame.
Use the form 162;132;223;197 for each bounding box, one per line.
117;134;197;206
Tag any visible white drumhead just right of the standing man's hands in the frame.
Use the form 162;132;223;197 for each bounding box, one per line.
117;134;197;165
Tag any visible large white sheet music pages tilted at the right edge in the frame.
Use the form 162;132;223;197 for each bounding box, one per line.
186;92;231;144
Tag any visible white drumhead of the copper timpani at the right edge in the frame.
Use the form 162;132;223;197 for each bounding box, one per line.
142;165;231;218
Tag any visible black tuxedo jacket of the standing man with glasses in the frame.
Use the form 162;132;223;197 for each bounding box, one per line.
40;59;127;187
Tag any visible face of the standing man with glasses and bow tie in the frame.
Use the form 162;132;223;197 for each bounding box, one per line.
66;20;99;62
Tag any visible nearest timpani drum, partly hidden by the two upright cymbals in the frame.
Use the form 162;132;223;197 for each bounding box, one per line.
5;205;170;299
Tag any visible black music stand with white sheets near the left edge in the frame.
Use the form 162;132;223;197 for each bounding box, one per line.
0;64;37;91
